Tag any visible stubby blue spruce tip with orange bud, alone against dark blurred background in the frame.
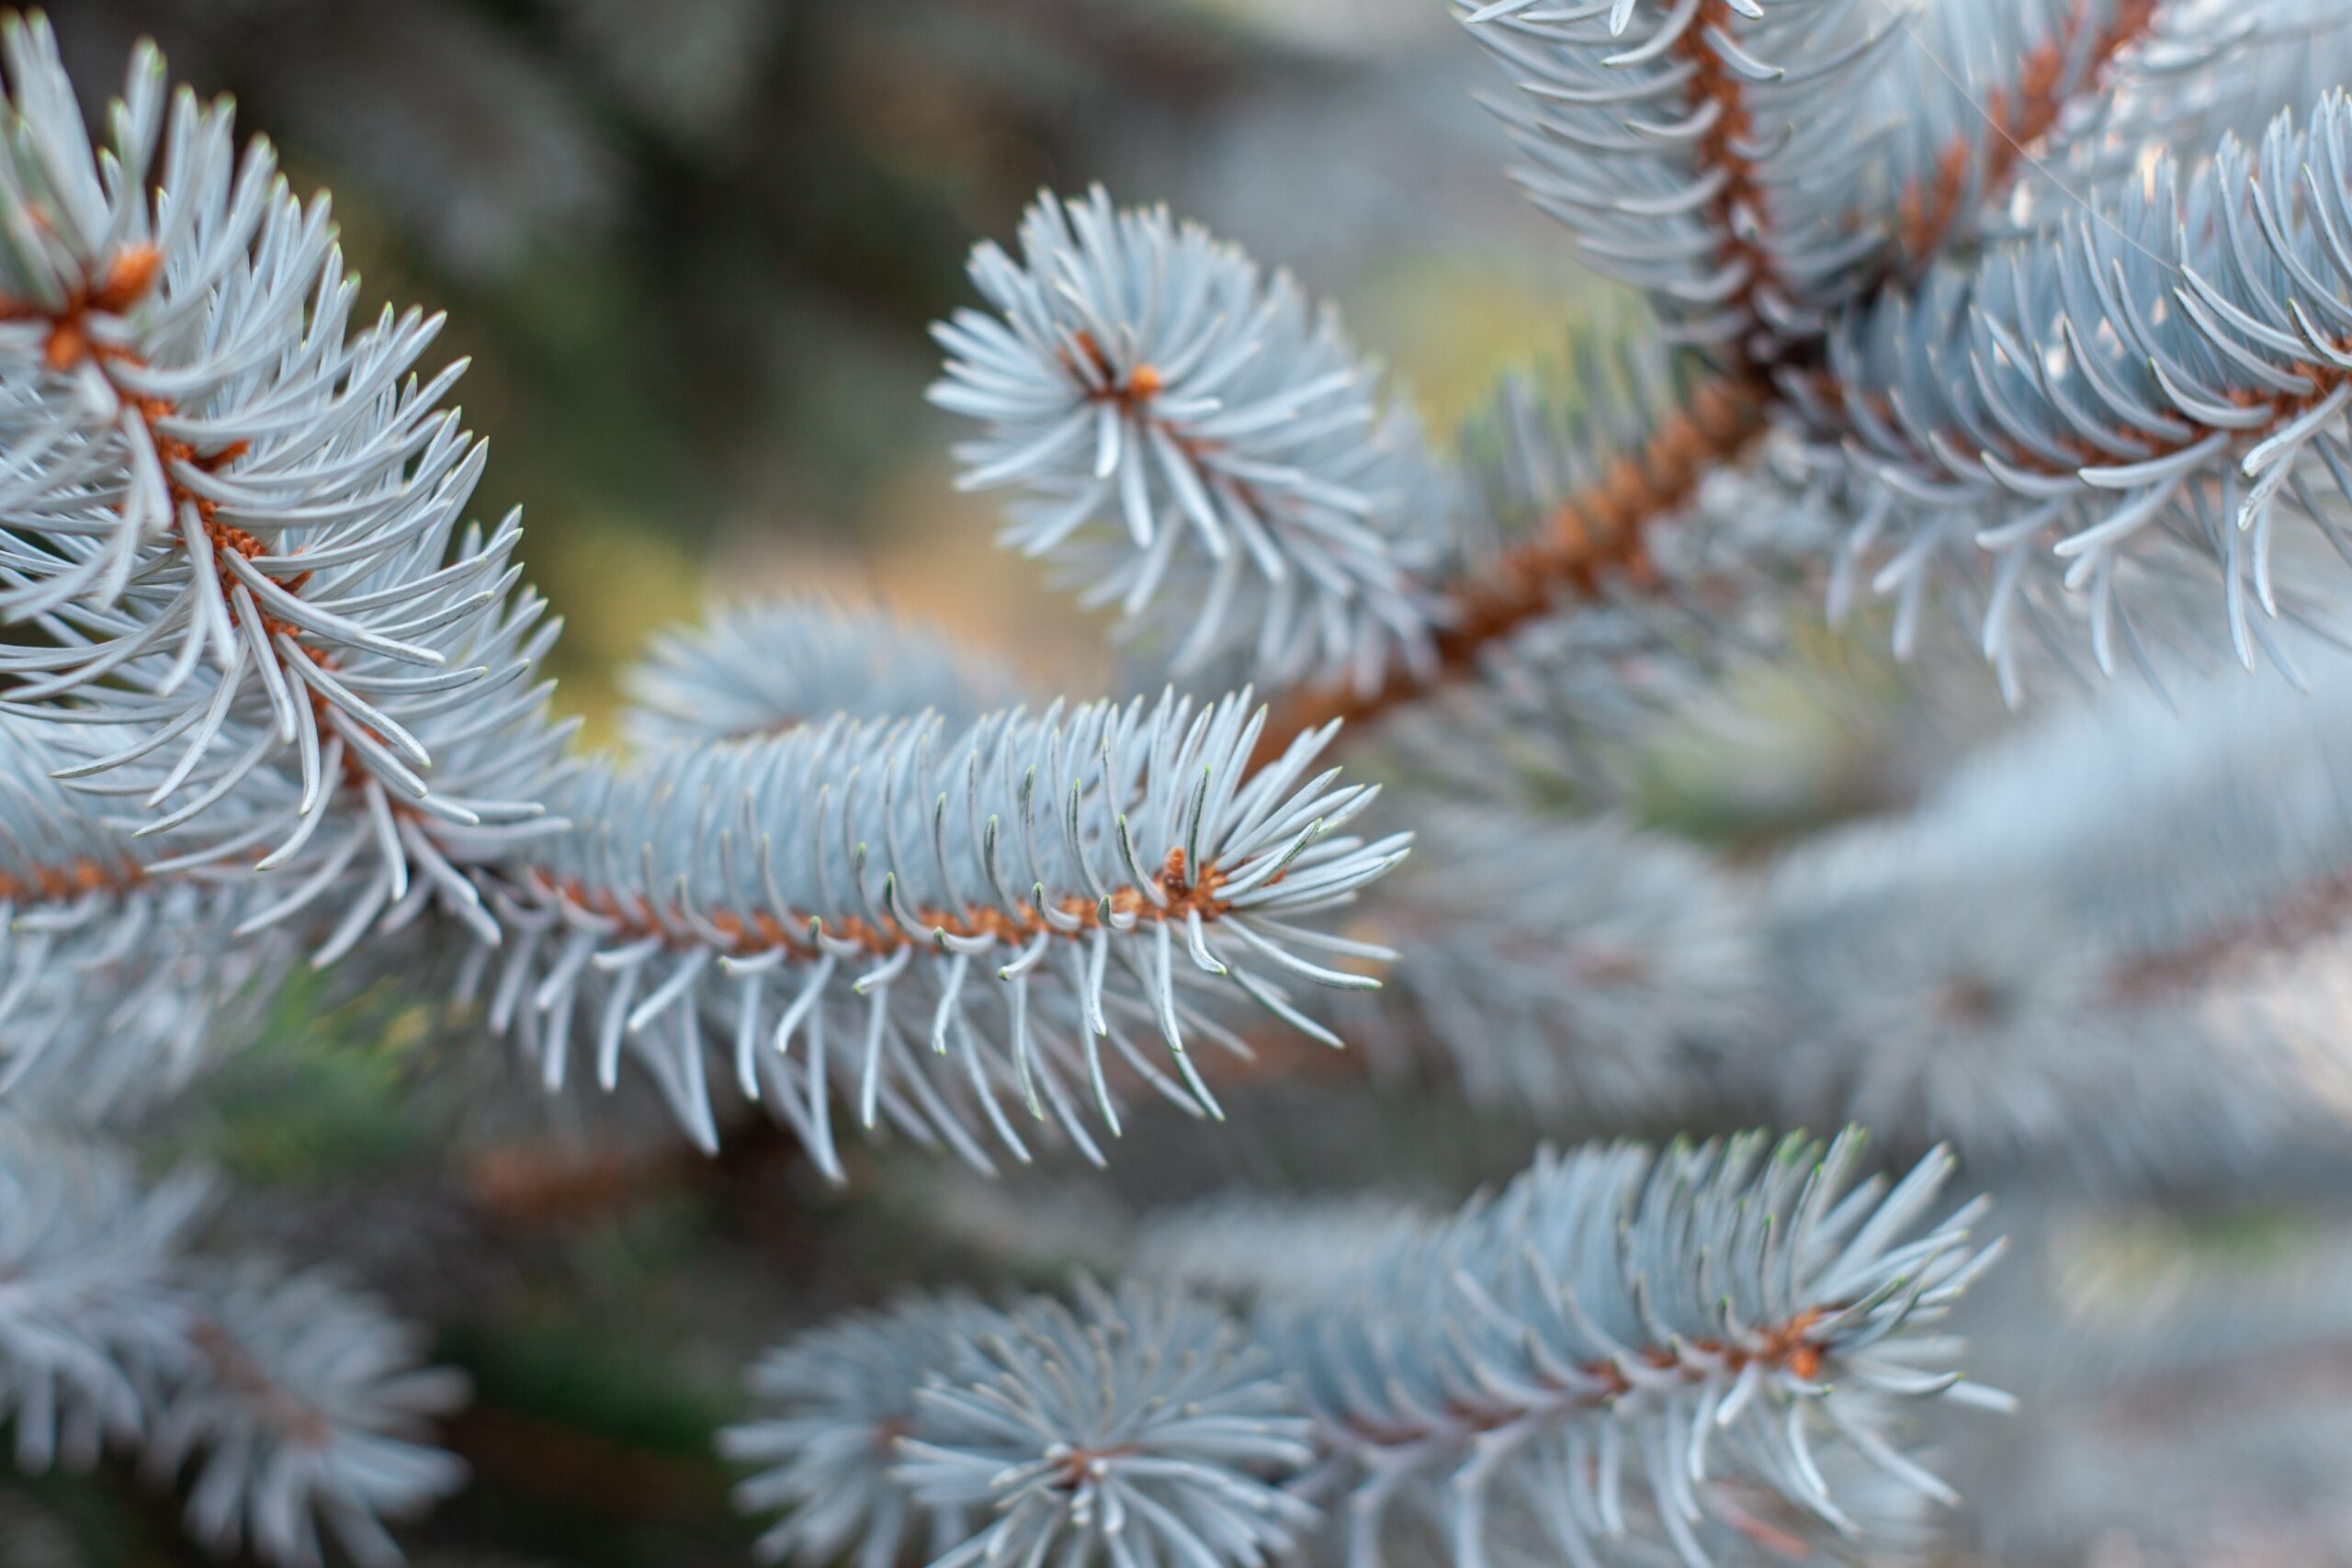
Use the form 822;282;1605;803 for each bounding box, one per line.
932;188;1449;689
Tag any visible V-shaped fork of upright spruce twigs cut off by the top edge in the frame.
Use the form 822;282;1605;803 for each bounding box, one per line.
1456;0;2157;352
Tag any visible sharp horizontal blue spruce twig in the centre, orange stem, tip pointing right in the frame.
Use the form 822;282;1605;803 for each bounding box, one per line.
492;698;1408;1176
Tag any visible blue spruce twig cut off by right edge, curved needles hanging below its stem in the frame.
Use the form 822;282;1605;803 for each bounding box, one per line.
1785;92;2352;670
